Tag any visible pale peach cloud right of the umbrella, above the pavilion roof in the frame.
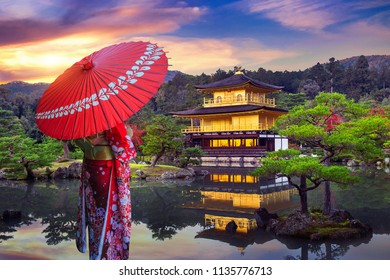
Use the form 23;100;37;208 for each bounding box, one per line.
134;36;296;75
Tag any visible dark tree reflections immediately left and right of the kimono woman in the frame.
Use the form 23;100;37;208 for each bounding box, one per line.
0;180;203;245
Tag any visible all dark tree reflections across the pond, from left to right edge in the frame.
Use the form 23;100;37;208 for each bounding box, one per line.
0;168;390;254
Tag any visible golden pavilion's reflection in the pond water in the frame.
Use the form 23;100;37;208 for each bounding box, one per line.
189;168;298;233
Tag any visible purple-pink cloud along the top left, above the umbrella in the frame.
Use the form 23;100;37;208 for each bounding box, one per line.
0;0;205;46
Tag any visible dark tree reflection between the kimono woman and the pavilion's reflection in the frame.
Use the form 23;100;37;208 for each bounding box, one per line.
132;187;203;240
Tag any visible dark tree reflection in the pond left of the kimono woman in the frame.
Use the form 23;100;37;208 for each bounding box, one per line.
0;180;78;245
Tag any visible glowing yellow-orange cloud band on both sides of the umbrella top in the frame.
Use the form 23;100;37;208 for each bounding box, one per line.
0;31;295;83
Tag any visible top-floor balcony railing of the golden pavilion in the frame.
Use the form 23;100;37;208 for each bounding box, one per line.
203;96;276;107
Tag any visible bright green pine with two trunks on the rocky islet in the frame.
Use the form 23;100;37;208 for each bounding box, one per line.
253;93;390;214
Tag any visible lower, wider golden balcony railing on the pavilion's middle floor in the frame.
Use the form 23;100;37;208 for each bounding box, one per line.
182;123;269;133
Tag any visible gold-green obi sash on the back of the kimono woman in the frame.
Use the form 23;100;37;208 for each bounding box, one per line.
74;135;114;160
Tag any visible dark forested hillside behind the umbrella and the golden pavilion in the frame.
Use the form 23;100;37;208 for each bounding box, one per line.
0;55;390;142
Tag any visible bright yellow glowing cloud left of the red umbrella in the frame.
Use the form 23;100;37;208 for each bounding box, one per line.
0;34;116;83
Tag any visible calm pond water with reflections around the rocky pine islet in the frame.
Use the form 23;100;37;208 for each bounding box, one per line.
0;168;390;260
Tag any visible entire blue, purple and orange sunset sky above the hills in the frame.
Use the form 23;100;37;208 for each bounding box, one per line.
0;0;390;84
